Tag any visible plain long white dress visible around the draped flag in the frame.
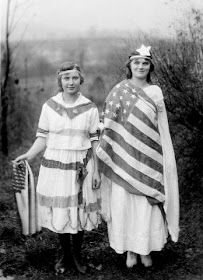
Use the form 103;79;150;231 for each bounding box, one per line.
101;85;179;255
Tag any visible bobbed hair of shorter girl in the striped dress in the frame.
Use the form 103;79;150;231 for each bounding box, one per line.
57;61;84;91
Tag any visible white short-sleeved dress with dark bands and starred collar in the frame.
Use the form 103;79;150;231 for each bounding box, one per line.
37;93;101;233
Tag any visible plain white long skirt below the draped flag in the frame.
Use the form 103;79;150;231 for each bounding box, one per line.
101;176;168;255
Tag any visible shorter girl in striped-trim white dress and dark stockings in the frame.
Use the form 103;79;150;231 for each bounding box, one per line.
15;62;101;273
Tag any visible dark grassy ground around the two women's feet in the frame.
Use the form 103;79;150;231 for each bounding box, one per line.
0;147;203;280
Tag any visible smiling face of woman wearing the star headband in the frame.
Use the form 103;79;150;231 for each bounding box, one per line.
130;58;150;79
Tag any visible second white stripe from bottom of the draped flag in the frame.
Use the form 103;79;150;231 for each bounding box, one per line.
103;135;163;182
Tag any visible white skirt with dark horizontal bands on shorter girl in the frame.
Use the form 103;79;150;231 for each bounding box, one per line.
37;149;101;233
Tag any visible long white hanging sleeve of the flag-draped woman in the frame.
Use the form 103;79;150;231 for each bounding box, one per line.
156;97;179;242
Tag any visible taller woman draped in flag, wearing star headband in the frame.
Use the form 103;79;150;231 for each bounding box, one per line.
97;45;179;267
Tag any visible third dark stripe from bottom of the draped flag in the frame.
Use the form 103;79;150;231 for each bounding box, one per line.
104;129;163;173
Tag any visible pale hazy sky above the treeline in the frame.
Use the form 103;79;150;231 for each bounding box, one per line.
0;0;203;40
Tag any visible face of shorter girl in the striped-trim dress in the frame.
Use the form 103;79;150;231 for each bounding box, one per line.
61;70;80;95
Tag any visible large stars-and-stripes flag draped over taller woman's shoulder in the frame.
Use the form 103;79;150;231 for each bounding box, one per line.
97;80;165;204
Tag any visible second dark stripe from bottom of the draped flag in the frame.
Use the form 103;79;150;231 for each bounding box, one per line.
101;139;163;192
